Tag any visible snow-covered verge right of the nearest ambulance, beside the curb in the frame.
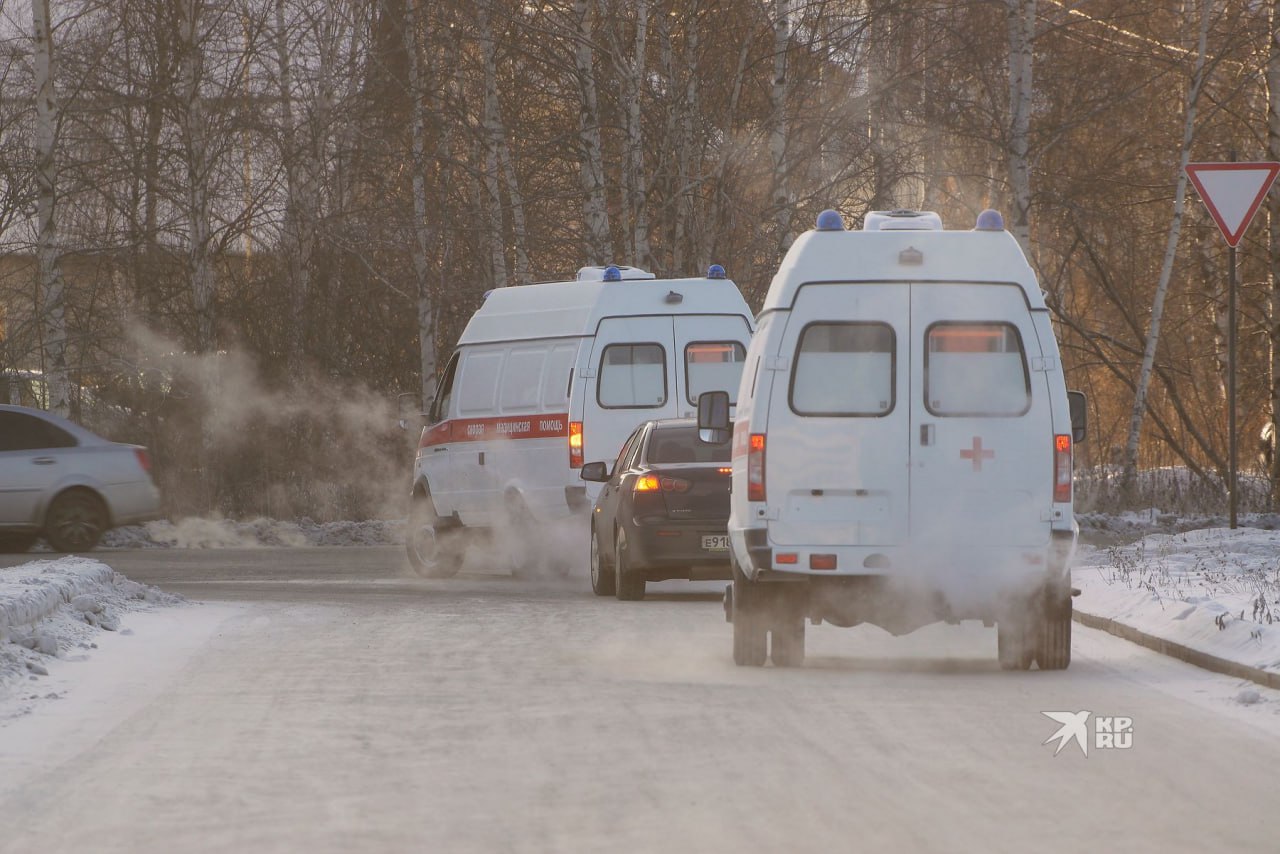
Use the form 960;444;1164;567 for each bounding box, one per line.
1073;528;1280;686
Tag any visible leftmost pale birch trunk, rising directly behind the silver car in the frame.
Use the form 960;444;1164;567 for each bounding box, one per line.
31;0;70;416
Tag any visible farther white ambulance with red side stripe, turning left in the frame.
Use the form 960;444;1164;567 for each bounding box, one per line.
406;264;754;576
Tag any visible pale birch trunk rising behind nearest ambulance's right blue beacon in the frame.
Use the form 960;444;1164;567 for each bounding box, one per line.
1006;0;1036;257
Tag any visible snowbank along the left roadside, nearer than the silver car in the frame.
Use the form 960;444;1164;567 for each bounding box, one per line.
0;557;184;721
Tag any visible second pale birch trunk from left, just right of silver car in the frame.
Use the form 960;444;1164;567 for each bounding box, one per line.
178;0;215;353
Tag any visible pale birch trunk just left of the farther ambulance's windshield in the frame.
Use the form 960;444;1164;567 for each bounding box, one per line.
404;0;435;407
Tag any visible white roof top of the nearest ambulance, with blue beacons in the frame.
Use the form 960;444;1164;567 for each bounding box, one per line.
762;211;1044;314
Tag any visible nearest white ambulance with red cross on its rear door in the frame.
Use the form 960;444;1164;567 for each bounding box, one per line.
699;211;1084;670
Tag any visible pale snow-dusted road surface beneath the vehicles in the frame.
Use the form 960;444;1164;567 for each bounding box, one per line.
0;548;1280;854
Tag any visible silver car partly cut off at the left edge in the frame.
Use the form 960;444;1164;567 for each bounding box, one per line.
0;405;160;552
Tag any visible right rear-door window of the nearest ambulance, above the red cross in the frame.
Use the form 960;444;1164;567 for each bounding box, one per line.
924;323;1032;416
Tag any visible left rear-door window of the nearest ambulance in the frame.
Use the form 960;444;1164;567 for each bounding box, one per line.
791;323;896;417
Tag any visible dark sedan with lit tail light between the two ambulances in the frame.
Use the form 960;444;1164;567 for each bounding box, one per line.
582;419;731;599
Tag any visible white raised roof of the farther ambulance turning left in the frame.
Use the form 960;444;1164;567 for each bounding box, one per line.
458;268;753;346
